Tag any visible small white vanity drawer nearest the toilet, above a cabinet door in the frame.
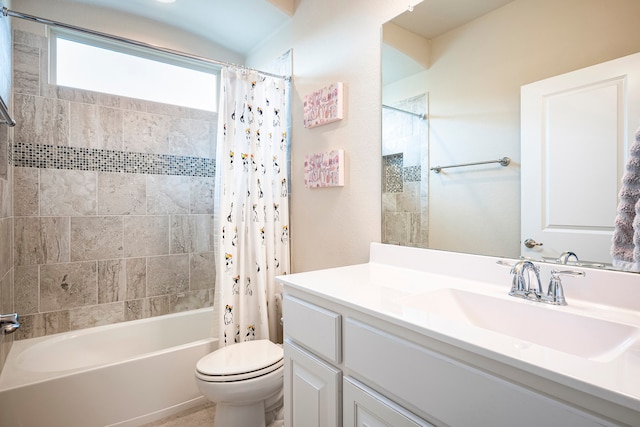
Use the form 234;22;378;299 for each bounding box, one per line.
283;294;342;363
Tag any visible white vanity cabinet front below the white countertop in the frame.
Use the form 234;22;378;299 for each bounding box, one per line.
283;286;615;427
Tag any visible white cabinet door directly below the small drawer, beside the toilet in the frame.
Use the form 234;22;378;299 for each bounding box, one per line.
284;340;342;427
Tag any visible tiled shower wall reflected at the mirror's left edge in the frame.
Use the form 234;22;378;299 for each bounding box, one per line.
382;95;429;248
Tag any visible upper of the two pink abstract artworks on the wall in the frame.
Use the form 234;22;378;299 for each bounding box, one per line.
303;82;342;128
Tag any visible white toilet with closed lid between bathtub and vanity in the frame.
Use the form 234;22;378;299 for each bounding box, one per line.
196;340;284;427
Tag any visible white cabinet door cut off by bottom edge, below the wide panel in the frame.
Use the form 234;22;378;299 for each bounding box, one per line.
343;378;433;427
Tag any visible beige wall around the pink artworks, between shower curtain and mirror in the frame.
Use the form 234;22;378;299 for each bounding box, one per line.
247;0;408;272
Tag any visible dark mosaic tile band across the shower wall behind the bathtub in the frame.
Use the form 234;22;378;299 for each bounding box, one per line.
10;143;216;177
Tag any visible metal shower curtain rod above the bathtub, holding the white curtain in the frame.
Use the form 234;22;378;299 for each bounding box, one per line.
2;7;291;81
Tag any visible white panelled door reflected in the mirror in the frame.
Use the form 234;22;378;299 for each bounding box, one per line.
521;54;640;262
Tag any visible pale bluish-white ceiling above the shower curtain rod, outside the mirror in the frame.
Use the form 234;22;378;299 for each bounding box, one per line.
59;0;291;55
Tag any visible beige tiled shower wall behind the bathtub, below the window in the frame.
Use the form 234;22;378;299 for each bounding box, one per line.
13;30;217;339
